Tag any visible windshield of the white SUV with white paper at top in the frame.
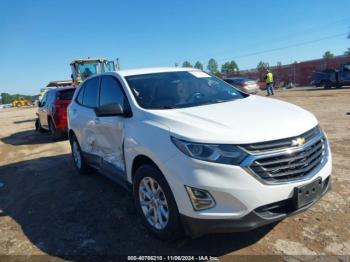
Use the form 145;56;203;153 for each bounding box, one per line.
126;71;247;109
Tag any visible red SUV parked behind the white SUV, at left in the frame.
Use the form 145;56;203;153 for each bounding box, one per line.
35;87;75;140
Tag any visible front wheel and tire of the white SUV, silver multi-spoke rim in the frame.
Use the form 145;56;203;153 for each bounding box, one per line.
133;164;184;241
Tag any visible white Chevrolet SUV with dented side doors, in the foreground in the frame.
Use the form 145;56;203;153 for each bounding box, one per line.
68;68;332;239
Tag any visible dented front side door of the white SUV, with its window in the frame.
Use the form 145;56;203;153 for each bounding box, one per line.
95;75;129;175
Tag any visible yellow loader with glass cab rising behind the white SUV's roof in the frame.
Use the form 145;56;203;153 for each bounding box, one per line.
70;58;116;86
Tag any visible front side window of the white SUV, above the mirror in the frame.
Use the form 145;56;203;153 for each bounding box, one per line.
100;76;125;107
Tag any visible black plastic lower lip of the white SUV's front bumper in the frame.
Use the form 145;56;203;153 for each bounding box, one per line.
181;176;331;238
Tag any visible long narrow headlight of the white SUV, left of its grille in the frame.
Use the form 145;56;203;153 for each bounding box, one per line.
171;137;247;165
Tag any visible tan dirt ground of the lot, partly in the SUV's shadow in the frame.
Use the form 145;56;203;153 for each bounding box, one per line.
0;89;350;260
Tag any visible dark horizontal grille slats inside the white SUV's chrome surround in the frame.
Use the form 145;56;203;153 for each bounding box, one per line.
245;131;327;182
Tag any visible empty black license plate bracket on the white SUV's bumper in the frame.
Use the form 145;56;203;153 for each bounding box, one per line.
293;178;323;209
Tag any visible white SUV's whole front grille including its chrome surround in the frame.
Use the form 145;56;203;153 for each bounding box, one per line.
241;127;328;184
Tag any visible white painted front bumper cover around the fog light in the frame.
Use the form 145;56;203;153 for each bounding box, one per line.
160;147;332;220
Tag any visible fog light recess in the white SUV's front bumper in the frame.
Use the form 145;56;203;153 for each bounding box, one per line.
185;186;215;210
